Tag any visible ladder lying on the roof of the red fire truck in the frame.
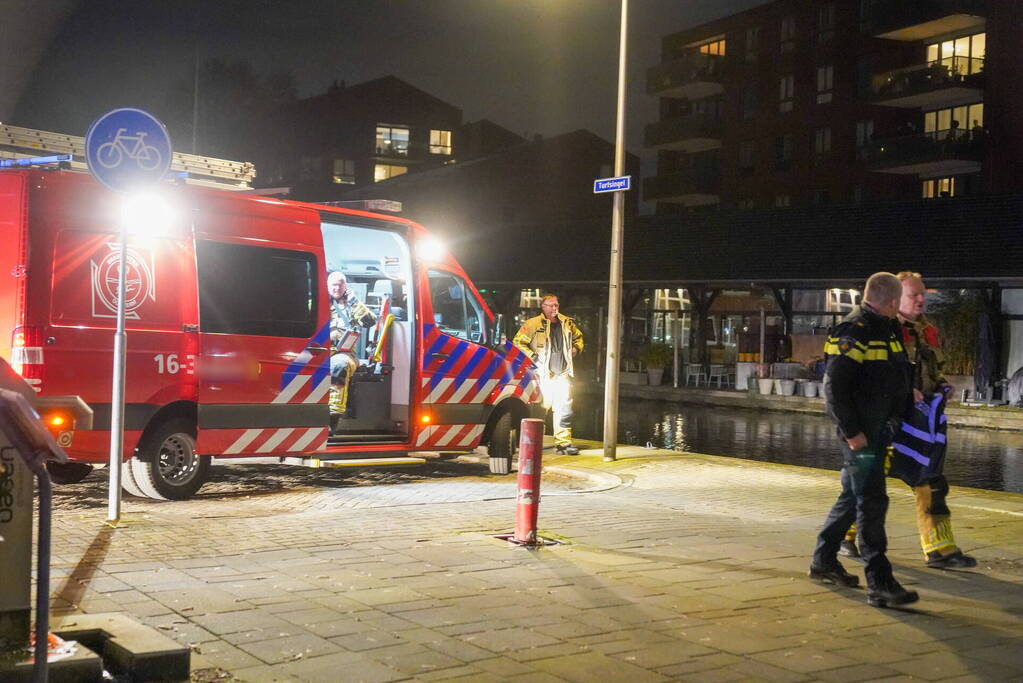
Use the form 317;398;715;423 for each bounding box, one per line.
0;124;256;190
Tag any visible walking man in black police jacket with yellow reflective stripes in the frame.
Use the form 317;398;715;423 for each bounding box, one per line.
809;273;919;607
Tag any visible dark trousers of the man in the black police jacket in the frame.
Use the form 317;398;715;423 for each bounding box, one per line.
813;440;892;588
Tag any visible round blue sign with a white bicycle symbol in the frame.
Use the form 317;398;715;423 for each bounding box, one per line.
85;107;172;191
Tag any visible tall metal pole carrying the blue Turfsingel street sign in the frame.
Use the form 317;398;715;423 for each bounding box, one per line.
604;0;629;462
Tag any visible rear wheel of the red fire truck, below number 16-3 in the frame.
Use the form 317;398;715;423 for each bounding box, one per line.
128;418;210;500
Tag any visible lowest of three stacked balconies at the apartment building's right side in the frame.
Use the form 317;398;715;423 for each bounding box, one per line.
866;131;987;178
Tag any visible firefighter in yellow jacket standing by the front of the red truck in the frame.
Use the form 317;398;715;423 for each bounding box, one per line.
513;294;582;455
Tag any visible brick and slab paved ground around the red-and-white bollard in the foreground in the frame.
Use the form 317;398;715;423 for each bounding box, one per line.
39;448;1023;683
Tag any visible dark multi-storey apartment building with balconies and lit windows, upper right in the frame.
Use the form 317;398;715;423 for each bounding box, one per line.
643;0;1023;215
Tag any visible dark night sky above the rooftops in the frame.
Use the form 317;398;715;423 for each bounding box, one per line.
0;0;763;166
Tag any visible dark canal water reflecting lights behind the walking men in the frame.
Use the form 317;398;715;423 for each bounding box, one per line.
574;394;1023;493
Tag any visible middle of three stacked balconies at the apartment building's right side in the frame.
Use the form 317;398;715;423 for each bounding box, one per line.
873;57;984;109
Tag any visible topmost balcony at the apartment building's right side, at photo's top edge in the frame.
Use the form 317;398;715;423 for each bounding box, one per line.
872;0;982;42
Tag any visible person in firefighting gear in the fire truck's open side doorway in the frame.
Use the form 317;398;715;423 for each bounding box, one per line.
326;270;376;422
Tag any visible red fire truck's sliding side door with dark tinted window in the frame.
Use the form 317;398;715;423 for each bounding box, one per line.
195;240;330;455
